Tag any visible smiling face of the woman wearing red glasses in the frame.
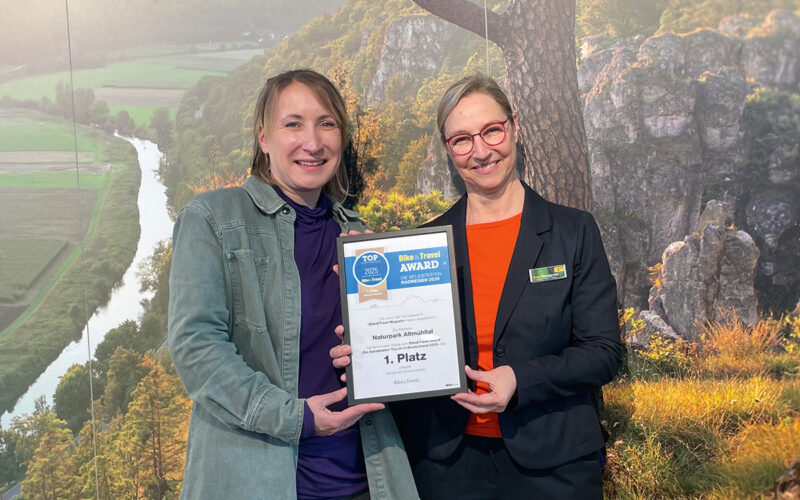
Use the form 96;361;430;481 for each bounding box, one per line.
444;92;519;196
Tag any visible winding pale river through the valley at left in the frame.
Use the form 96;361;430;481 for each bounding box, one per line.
0;138;172;429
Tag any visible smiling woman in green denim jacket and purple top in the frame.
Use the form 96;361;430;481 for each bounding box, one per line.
169;70;417;500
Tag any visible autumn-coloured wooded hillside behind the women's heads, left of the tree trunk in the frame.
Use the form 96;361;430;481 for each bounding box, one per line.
165;0;502;208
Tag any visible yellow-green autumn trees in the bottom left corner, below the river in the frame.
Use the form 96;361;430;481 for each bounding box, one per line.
11;356;191;500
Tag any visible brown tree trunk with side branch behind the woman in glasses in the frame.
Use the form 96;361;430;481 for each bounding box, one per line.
414;0;592;210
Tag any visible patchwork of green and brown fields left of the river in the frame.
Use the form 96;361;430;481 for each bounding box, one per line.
0;109;110;333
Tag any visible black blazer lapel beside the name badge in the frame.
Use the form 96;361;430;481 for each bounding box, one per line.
490;184;551;346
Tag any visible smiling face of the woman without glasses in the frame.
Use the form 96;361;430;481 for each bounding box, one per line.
258;82;342;207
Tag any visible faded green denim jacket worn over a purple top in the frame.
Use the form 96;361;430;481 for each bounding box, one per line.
169;177;417;500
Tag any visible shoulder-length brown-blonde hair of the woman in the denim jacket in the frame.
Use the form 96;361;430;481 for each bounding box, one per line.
250;69;350;201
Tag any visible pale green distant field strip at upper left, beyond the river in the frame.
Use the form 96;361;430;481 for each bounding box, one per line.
0;62;225;101
